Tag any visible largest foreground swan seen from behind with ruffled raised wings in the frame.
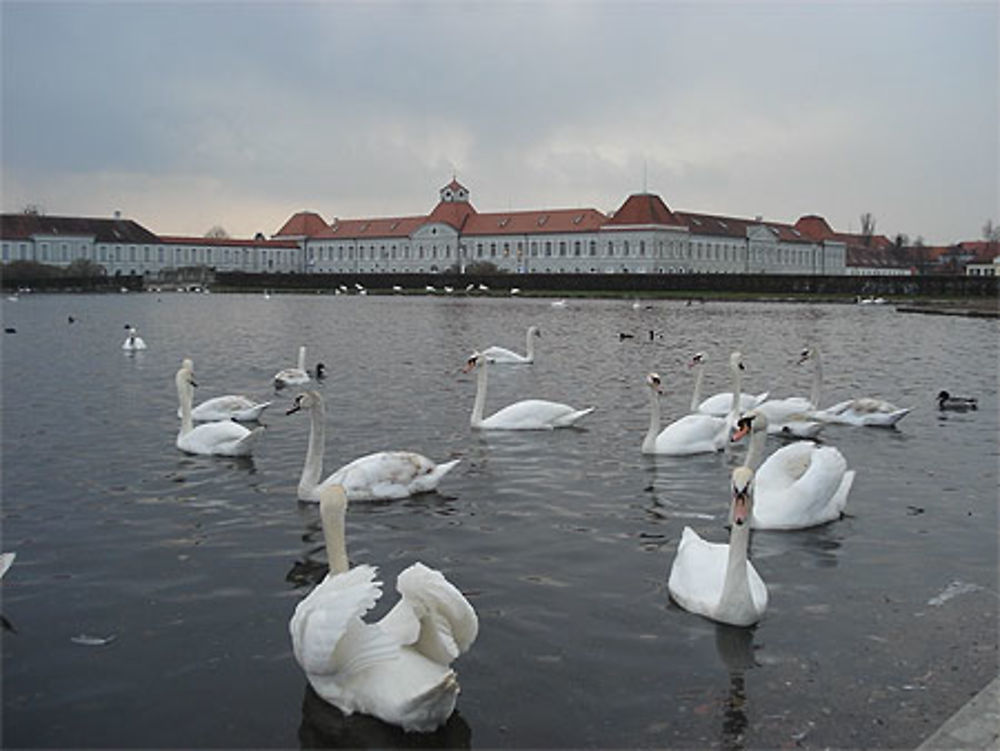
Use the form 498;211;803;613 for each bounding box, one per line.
288;485;479;732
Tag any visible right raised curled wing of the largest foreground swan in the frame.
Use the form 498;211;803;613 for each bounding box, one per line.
379;563;479;666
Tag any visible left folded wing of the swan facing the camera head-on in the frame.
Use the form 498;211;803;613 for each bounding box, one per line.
667;527;729;615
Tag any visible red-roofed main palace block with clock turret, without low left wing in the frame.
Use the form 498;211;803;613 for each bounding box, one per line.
274;180;847;274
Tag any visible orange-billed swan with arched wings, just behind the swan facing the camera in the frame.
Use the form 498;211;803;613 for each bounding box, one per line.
732;410;855;529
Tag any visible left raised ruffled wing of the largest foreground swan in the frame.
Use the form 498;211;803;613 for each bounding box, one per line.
288;566;397;678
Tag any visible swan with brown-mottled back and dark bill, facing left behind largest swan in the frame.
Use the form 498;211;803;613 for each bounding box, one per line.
286;391;460;501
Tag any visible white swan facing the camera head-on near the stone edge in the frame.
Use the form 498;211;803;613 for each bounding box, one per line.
667;467;767;626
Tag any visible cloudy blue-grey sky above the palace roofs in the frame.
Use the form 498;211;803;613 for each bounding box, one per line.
0;0;1000;244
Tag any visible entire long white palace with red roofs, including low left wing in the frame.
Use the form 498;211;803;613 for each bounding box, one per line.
0;179;855;278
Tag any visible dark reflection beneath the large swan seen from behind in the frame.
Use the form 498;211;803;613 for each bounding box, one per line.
299;683;472;749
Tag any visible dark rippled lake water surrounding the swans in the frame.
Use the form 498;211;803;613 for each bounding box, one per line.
0;293;998;748
